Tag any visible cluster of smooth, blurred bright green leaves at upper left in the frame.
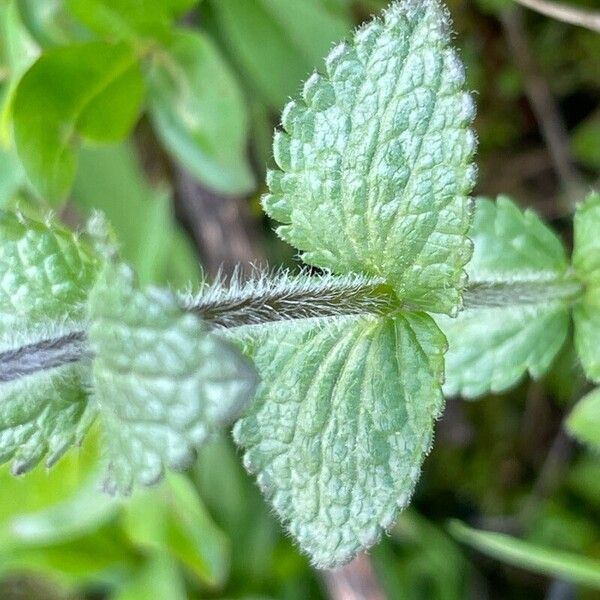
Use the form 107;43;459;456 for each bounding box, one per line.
13;0;254;202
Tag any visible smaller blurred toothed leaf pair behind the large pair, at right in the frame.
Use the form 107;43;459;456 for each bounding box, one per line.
436;196;569;398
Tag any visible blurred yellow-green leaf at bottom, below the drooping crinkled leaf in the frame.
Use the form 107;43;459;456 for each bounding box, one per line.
124;474;229;586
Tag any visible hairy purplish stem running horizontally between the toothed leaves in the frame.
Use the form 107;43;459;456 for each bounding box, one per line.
0;272;582;382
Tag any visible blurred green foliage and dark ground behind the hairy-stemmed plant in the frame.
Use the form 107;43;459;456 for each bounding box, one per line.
0;0;600;600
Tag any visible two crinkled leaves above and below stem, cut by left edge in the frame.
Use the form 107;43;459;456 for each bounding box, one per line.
0;212;96;473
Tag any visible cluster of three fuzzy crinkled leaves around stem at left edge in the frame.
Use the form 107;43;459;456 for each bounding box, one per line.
0;213;255;493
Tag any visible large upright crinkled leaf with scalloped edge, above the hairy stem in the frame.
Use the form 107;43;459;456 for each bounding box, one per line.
263;0;476;314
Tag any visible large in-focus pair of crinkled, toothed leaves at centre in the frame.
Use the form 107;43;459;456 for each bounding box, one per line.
232;0;475;568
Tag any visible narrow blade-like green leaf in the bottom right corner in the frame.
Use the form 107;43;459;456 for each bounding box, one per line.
450;521;600;589
